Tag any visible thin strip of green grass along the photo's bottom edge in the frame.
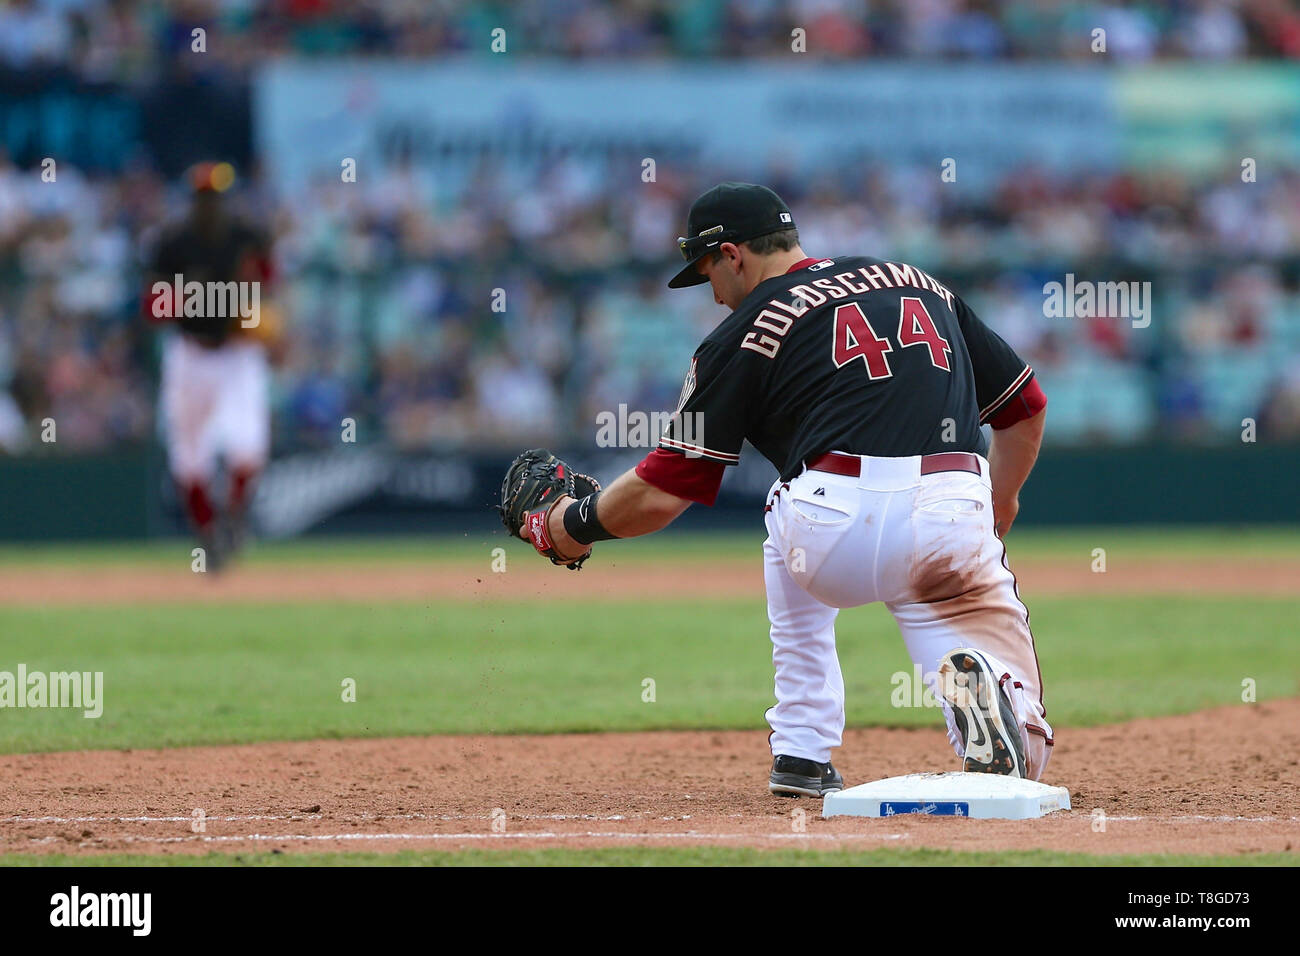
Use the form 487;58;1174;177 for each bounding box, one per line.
0;847;1300;866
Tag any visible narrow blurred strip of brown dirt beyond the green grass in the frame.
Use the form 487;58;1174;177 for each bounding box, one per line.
0;553;1300;605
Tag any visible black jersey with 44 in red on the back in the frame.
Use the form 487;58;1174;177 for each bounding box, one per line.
659;256;1034;480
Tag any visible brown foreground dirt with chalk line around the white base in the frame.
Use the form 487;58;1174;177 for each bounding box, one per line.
0;700;1300;855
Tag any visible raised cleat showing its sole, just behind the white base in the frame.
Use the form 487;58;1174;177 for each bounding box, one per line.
939;648;1024;778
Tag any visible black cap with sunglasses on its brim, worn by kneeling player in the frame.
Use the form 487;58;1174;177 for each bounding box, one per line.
668;182;794;289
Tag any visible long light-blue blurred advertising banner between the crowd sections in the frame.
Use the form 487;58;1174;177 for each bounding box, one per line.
255;61;1118;191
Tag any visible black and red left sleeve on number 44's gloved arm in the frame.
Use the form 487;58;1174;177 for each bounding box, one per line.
637;342;759;505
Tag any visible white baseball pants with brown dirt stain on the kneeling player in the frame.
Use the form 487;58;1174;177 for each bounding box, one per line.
763;455;1053;779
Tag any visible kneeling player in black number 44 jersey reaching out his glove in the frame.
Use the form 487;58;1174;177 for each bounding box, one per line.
502;182;1053;796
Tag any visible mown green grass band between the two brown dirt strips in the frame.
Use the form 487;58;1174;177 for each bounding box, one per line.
0;594;1300;753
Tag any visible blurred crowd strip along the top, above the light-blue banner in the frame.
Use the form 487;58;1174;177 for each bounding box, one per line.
0;0;1300;70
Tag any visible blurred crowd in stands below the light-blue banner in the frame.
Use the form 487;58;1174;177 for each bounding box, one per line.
10;154;1300;450
